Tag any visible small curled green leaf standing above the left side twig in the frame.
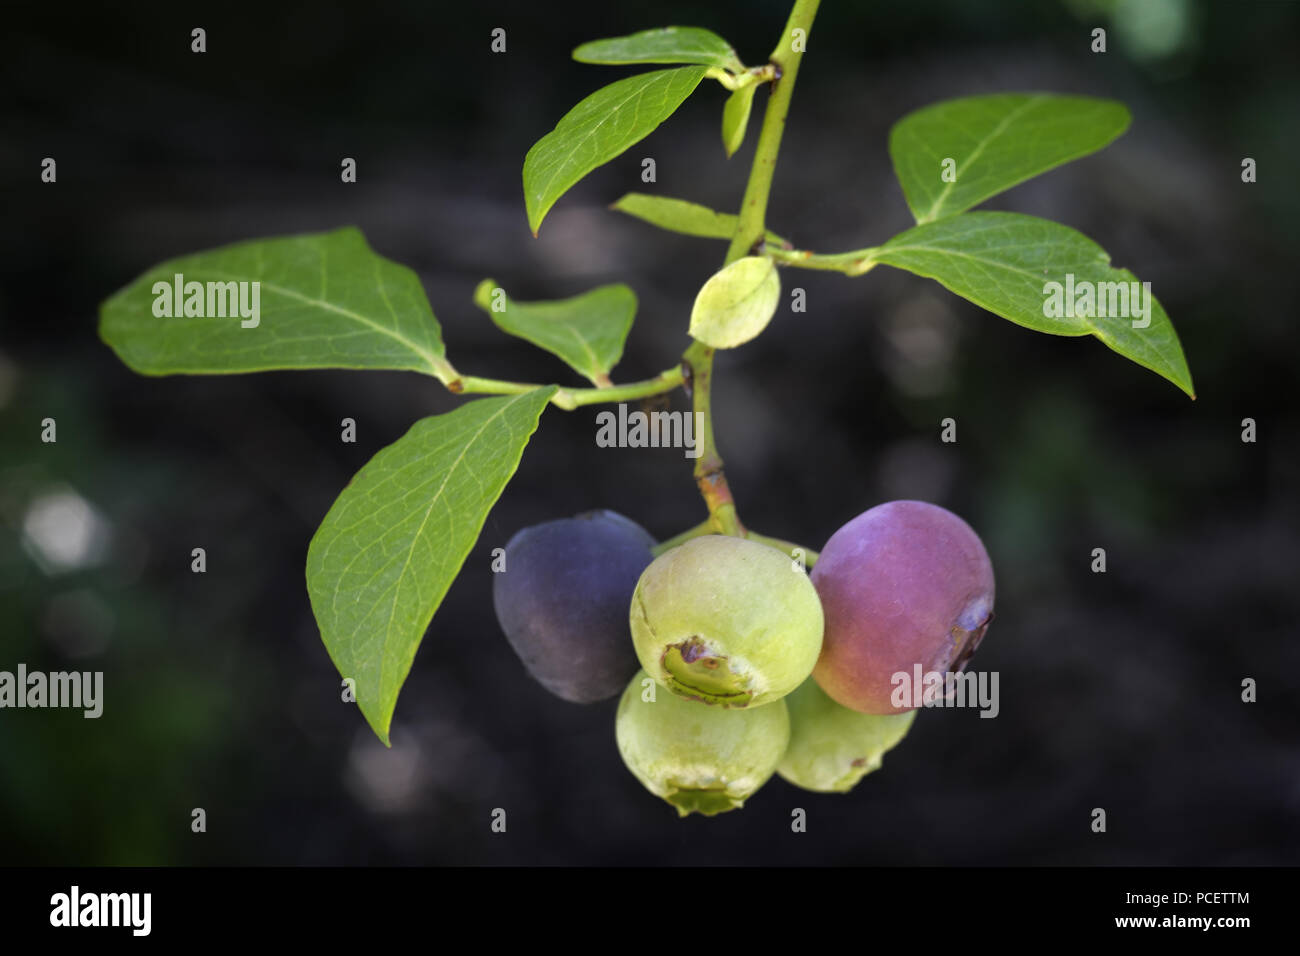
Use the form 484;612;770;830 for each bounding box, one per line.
475;278;637;385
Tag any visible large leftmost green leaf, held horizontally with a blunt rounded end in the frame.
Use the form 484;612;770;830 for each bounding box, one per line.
99;228;455;382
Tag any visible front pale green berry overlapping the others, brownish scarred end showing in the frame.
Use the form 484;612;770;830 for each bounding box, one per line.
631;535;822;708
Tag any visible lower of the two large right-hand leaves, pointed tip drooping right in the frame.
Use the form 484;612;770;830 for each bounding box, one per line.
871;212;1196;398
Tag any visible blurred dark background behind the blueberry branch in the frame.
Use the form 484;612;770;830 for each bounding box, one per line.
0;0;1300;865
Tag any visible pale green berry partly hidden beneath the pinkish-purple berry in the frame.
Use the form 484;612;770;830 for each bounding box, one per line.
776;679;917;793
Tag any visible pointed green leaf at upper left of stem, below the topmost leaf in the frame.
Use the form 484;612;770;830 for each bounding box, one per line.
524;66;705;235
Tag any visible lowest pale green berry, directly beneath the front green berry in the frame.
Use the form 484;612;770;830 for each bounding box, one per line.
615;671;790;817
